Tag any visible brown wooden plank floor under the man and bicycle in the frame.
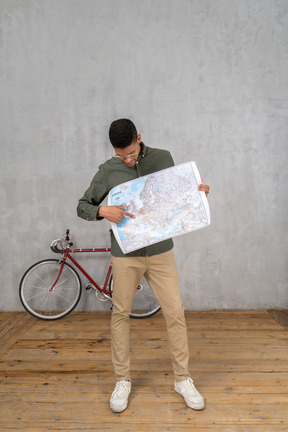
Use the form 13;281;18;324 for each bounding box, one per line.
0;311;288;432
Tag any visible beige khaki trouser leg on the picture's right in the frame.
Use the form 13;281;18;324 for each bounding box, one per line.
145;250;189;381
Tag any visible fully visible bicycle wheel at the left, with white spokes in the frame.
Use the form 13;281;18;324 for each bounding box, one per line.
19;259;82;320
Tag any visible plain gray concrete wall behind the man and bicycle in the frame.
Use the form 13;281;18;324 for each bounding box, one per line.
0;0;288;311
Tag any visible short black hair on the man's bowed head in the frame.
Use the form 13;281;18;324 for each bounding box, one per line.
109;119;137;149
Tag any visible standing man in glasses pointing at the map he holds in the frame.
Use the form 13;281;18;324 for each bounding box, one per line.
77;119;209;412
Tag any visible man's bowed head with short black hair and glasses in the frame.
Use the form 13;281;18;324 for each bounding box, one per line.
109;119;141;168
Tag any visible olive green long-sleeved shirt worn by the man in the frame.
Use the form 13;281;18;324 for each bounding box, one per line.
77;143;174;257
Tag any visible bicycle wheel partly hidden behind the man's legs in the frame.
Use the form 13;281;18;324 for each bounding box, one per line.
109;276;161;318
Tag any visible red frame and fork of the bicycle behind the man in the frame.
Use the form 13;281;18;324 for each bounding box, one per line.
50;246;112;295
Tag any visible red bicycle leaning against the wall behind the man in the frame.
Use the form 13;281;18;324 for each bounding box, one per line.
19;229;160;320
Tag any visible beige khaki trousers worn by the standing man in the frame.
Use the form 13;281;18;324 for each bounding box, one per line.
111;250;189;381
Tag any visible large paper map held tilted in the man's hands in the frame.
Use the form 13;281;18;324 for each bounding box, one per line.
108;162;210;254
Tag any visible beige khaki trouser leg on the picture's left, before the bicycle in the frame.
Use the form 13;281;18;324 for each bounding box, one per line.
111;256;145;381
